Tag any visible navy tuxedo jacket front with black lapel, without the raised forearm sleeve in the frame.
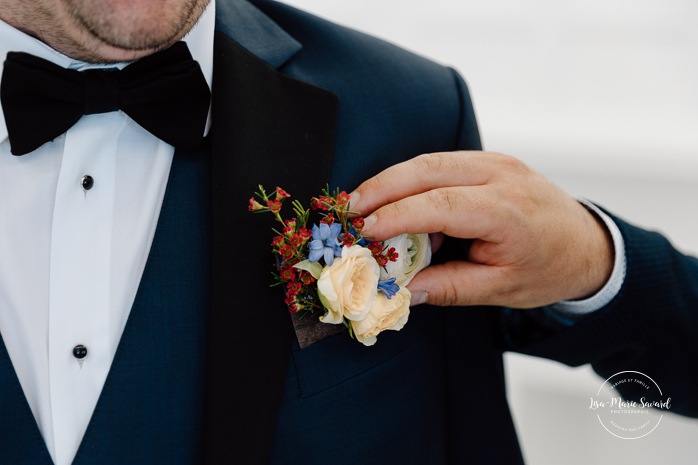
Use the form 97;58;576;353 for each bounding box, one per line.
198;1;521;464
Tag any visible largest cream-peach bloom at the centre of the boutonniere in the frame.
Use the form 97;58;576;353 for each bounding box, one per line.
317;245;380;324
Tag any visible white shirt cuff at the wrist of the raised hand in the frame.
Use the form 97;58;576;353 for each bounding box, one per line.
549;199;626;318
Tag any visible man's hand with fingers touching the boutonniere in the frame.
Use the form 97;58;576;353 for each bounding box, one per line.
351;152;614;308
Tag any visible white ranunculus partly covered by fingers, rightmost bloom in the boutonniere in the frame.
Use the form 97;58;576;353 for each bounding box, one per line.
381;234;431;288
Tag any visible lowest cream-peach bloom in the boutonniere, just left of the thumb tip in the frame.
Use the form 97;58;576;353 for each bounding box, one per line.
351;287;412;346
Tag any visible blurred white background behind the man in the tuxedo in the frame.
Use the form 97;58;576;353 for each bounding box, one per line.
286;0;698;465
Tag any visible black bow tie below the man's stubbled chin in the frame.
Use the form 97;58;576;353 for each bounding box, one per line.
0;42;211;155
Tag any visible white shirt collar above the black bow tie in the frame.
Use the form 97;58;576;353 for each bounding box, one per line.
0;1;216;143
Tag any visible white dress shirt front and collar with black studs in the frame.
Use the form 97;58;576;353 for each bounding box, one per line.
0;2;215;465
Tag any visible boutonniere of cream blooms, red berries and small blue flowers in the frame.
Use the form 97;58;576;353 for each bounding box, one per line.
249;186;431;346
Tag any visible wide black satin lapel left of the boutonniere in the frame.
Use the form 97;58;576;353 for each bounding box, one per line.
204;34;338;464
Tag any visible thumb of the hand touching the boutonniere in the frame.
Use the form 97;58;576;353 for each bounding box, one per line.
407;261;506;306
